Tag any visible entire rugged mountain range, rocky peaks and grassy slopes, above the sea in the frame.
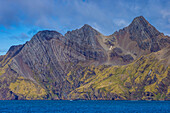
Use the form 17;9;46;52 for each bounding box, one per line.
0;16;170;100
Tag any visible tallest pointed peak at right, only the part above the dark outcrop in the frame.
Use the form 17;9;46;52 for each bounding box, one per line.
113;16;170;61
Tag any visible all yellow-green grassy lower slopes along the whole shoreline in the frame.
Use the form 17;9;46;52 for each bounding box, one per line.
0;48;170;100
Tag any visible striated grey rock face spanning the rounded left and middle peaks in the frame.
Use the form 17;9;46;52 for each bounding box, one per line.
6;25;106;98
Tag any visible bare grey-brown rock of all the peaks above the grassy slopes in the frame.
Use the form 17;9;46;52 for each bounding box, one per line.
0;17;170;99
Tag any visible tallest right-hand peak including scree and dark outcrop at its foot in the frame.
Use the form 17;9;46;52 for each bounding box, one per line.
106;16;170;64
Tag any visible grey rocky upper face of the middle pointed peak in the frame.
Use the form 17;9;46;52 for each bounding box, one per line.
65;24;106;61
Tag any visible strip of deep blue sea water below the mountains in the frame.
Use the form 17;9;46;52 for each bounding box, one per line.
0;100;170;113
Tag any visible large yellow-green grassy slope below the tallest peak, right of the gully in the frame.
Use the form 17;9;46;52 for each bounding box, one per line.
69;48;170;100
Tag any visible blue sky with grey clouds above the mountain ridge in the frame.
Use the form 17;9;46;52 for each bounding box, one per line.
0;0;170;55
